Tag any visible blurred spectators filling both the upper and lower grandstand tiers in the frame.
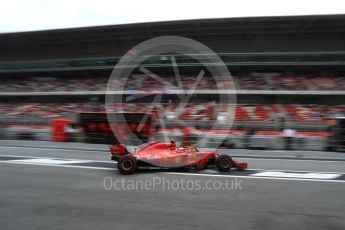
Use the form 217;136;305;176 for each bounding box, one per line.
0;72;345;126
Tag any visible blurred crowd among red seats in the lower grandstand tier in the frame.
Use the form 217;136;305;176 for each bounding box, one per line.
0;103;345;123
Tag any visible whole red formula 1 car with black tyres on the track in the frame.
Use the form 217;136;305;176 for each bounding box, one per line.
110;142;248;175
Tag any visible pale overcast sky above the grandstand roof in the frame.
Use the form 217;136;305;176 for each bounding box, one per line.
0;0;345;33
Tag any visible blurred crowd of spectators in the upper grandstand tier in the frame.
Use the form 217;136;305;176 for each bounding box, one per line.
0;73;345;92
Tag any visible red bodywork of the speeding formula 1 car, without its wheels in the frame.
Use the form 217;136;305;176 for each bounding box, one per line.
110;142;248;170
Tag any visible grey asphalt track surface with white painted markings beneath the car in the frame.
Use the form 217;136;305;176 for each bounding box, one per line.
0;147;345;229
